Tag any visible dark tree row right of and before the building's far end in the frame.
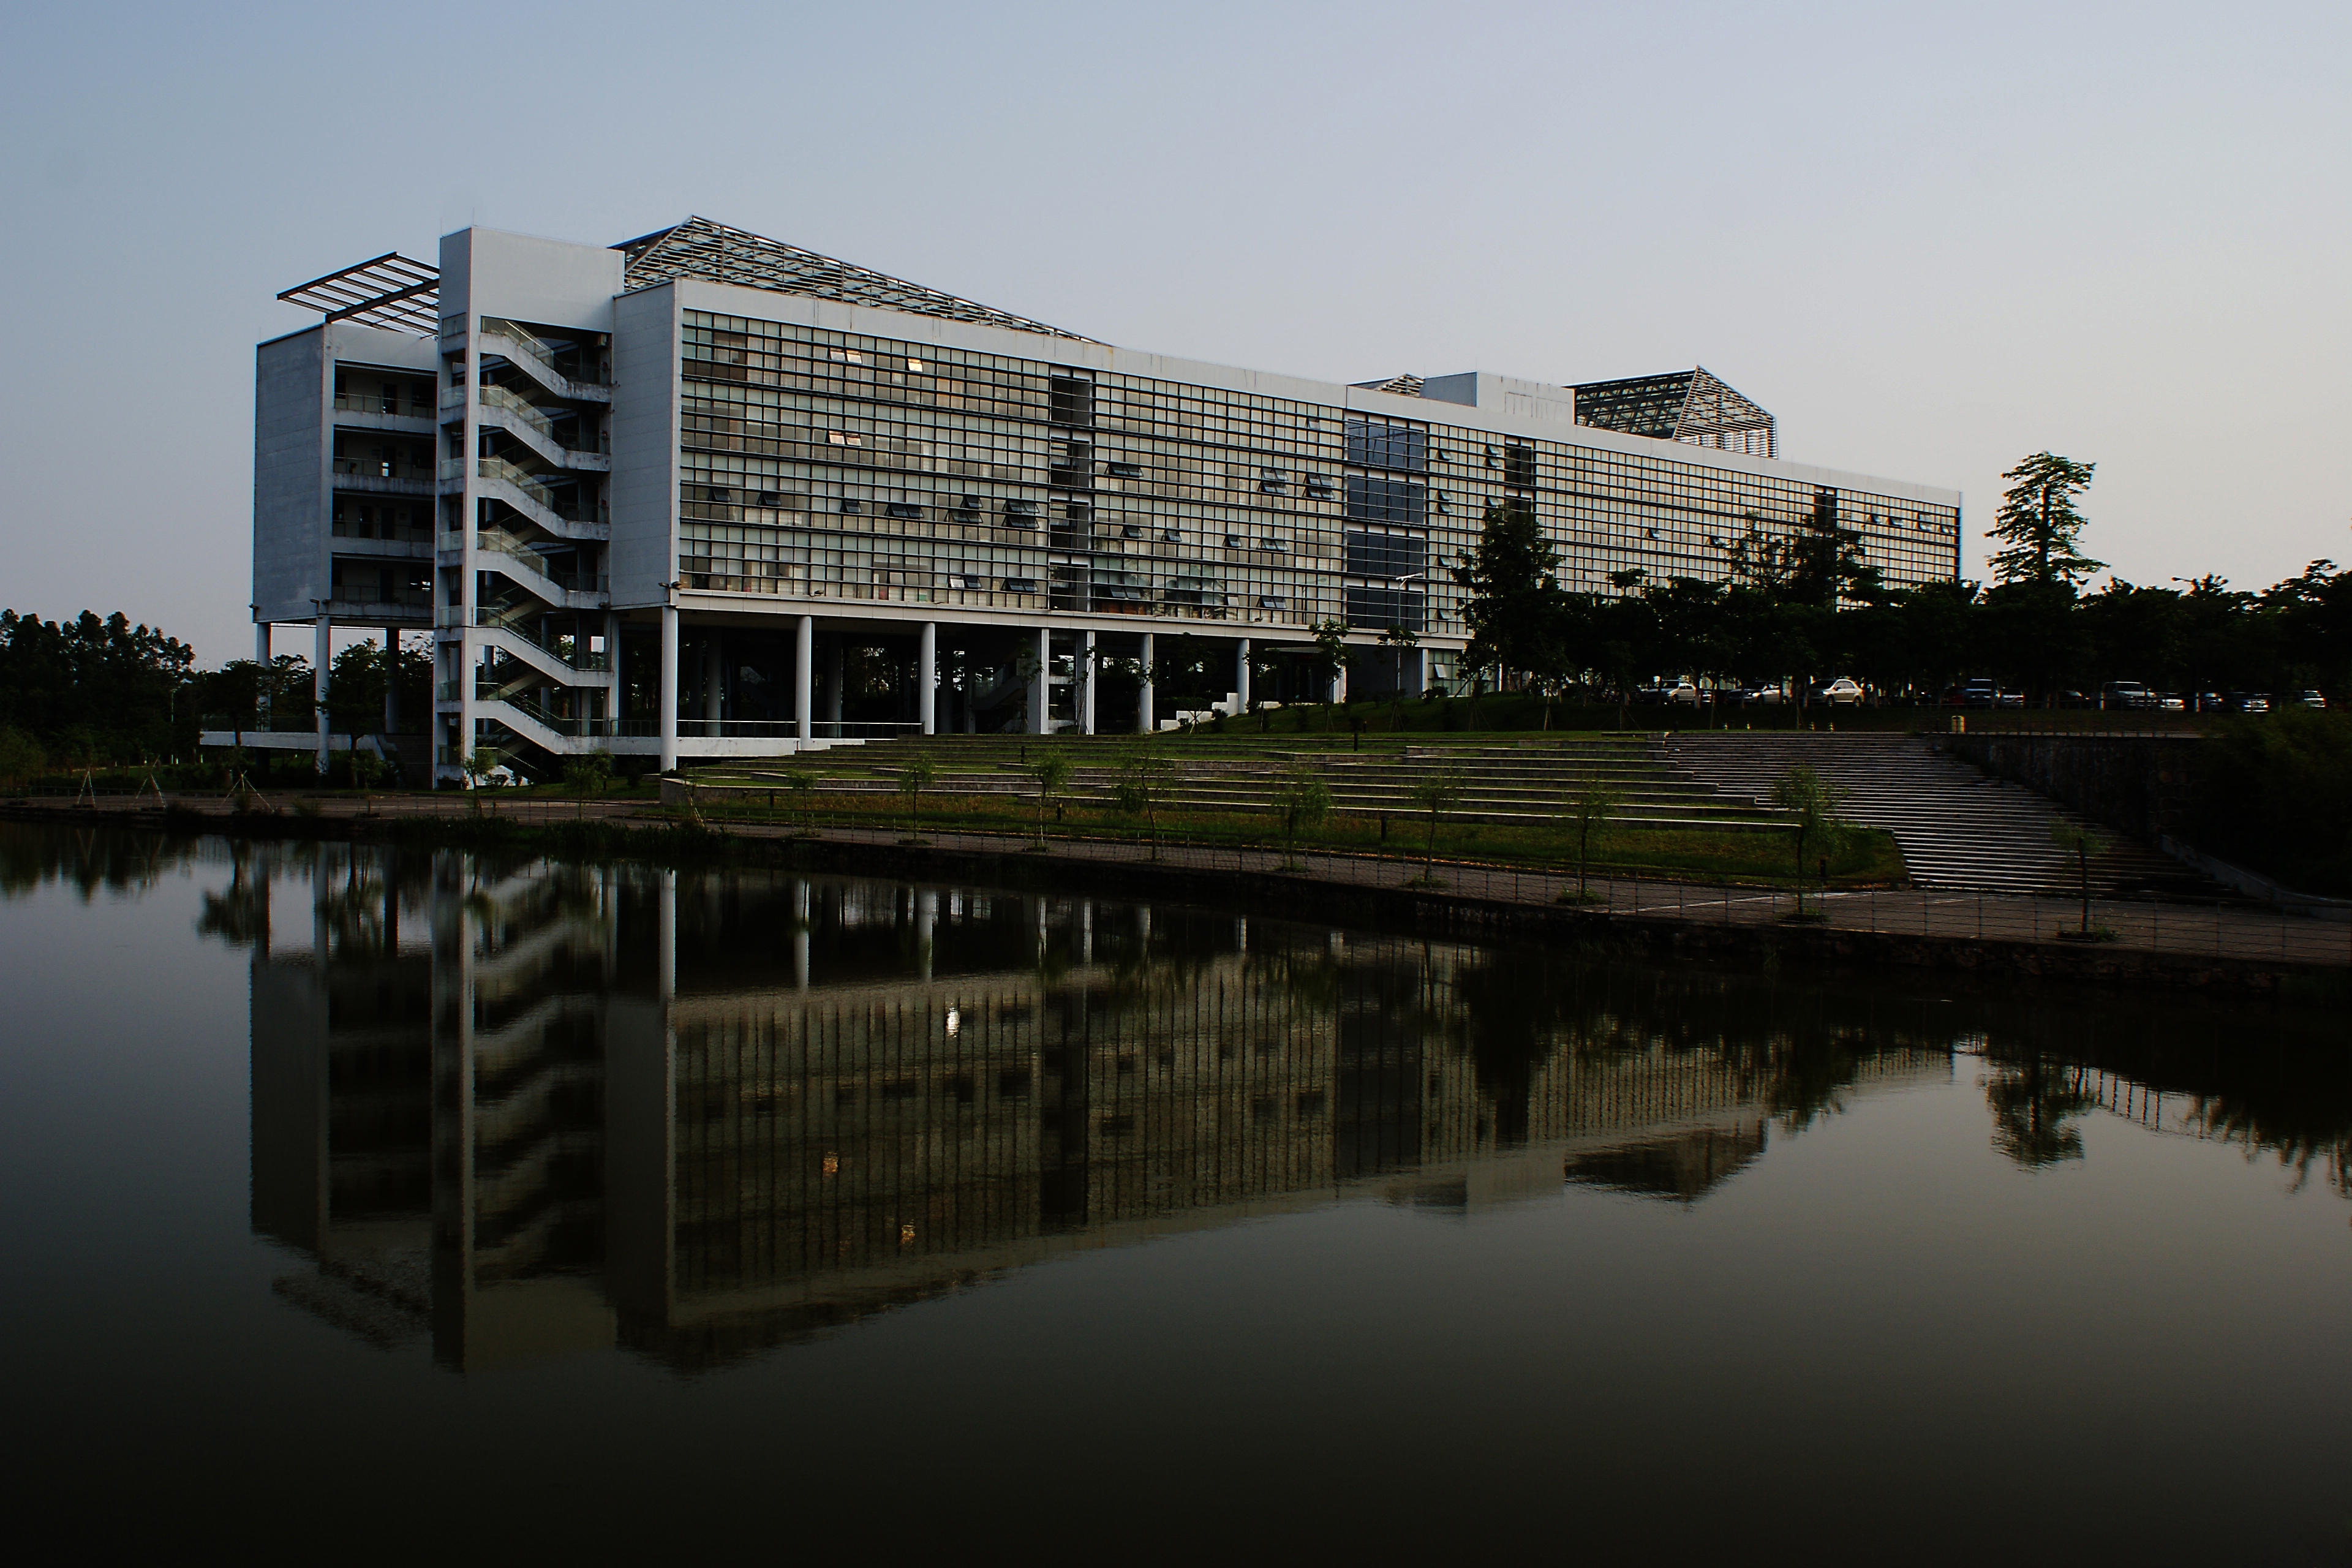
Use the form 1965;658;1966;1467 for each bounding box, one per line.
1451;451;2352;703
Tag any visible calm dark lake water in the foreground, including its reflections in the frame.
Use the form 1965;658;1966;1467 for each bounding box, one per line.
0;825;2352;1563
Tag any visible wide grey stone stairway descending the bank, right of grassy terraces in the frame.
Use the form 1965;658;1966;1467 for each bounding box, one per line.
1660;733;2227;900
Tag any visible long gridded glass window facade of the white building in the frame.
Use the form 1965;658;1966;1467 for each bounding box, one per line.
677;311;1959;637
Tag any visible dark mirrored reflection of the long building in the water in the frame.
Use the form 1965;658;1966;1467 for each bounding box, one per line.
252;846;1948;1368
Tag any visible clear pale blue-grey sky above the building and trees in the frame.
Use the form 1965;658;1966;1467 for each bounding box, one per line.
0;0;2352;663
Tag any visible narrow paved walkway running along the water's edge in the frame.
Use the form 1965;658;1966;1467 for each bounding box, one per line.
37;794;2352;966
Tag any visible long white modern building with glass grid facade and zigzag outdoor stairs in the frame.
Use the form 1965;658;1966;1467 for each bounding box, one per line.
238;219;1959;778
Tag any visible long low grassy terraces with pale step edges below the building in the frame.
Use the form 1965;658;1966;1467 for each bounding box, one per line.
698;736;1773;830
